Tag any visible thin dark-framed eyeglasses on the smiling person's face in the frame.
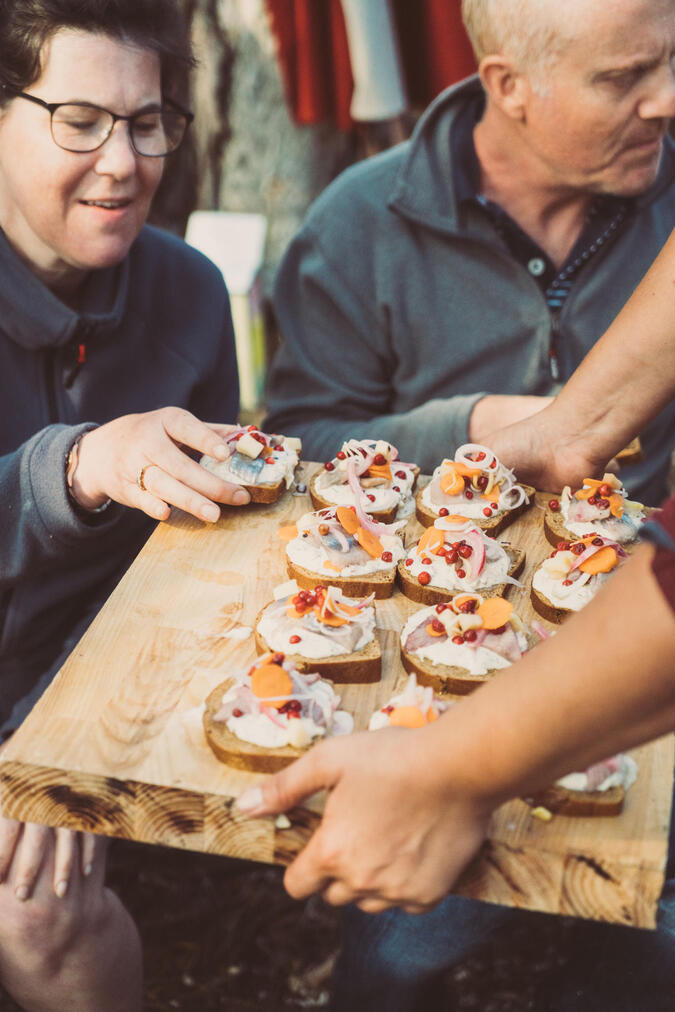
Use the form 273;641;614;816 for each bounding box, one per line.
2;84;194;158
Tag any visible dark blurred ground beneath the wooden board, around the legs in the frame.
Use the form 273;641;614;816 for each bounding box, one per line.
0;841;582;1012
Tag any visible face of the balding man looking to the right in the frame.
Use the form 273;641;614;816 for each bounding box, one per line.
522;0;675;196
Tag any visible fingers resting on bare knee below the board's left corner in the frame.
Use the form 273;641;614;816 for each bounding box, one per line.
0;816;105;901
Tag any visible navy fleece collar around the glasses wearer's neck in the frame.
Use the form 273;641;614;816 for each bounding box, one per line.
0;230;129;351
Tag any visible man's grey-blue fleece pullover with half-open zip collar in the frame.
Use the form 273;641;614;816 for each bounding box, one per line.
265;78;675;502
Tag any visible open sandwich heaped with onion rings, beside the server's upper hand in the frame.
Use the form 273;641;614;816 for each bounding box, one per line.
416;443;534;537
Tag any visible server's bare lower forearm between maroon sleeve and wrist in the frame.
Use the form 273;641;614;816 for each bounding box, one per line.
428;547;675;805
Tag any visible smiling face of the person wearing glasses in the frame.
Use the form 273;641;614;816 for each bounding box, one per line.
0;29;164;289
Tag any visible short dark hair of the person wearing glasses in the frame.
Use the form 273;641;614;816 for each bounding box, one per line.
0;0;194;107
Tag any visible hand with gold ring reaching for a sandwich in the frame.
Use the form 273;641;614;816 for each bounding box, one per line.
72;408;250;523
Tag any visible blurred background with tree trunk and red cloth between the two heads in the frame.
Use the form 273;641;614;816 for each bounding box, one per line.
152;0;476;420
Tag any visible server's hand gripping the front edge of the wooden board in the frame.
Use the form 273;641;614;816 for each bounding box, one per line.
238;719;490;913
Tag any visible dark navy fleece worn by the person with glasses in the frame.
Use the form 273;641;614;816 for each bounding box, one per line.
0;228;239;736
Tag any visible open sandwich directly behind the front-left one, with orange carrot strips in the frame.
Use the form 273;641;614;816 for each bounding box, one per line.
255;585;382;683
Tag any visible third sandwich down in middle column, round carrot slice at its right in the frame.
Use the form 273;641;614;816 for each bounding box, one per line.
401;594;538;695
